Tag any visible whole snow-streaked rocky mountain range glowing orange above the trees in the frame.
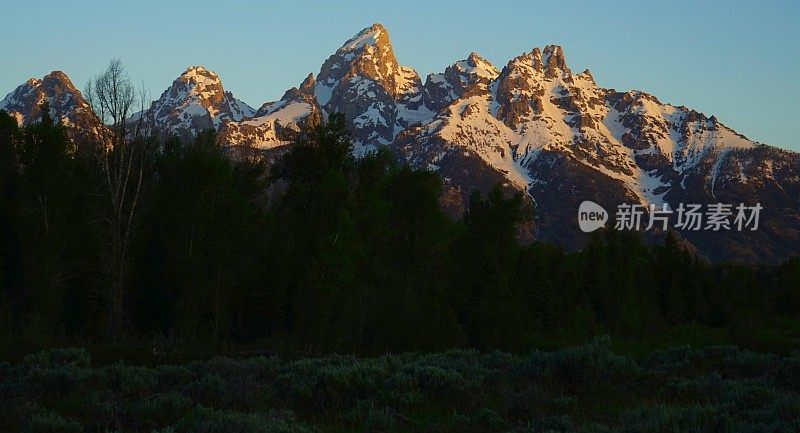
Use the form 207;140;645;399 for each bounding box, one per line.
0;24;800;260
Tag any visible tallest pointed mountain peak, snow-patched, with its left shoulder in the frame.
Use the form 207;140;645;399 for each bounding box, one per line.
222;23;418;149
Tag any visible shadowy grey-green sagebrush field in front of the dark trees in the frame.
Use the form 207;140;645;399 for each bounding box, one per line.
0;339;800;432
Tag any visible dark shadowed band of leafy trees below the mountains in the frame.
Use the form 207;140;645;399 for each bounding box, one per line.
0;107;800;355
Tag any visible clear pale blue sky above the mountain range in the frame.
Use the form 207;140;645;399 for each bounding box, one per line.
0;0;800;151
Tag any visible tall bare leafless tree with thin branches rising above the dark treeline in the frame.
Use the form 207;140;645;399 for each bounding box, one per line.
85;60;153;333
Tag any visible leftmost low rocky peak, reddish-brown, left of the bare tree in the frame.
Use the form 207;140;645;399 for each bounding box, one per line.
0;71;103;139
